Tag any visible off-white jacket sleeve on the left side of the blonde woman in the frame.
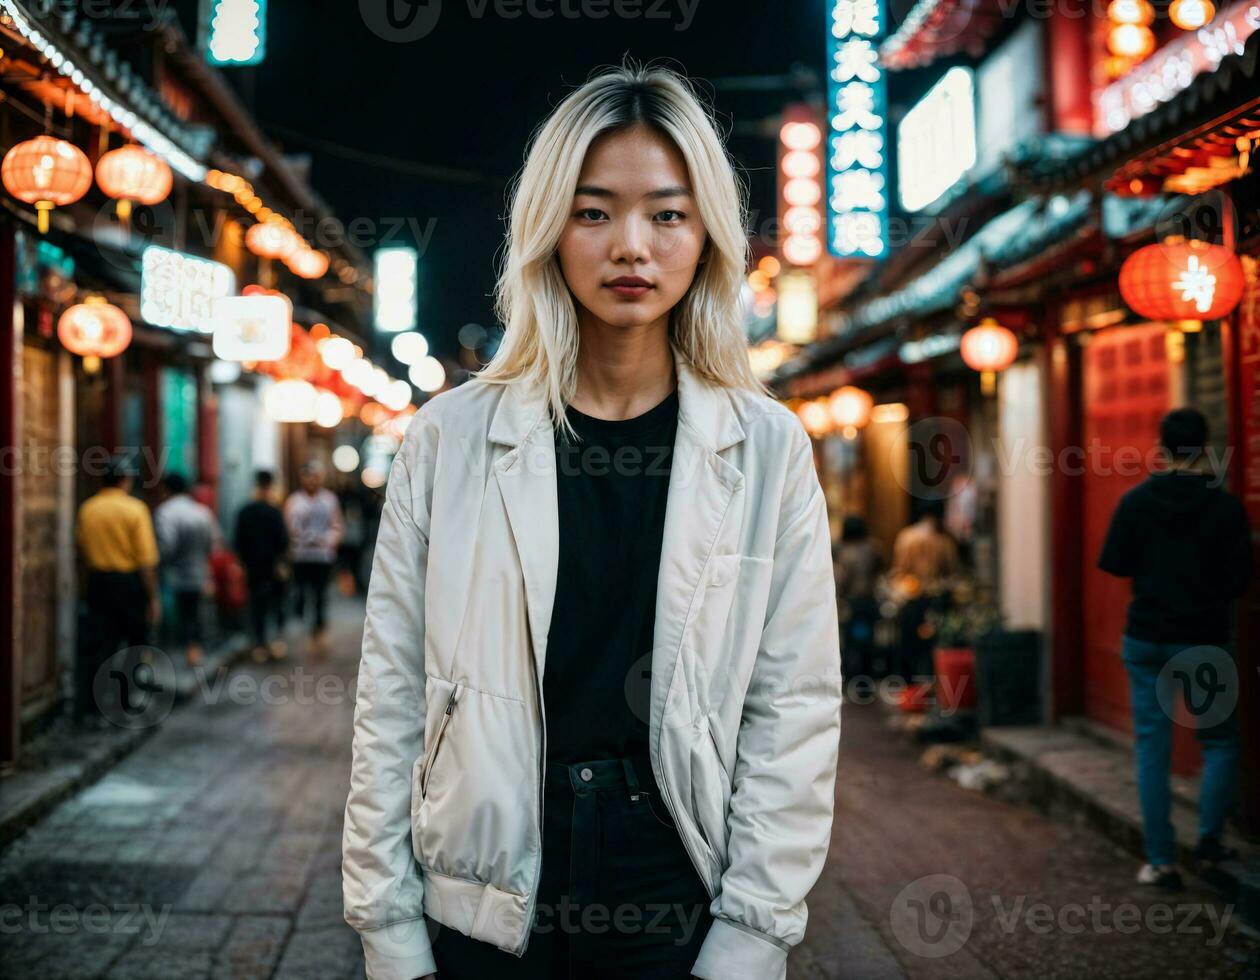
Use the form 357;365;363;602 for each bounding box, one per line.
341;414;436;980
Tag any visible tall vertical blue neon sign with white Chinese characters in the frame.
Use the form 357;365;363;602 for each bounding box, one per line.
827;0;888;258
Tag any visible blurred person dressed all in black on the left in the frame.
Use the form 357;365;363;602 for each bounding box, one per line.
236;470;289;663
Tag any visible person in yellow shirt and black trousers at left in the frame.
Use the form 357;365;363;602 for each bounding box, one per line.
74;459;160;719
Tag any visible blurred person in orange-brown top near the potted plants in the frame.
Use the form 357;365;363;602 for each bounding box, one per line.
890;499;959;680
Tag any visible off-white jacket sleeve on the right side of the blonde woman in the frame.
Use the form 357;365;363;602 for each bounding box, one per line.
692;424;840;980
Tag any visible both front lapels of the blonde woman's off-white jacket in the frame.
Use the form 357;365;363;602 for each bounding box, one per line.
489;350;745;735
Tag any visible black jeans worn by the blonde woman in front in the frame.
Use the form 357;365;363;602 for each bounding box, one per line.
427;760;713;980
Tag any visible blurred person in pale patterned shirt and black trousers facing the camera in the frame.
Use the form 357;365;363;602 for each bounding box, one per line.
285;461;345;654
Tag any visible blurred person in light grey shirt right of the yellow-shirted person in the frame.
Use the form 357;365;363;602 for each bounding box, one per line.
154;472;219;666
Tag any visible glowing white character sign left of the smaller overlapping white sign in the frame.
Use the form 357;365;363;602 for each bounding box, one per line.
140;246;236;334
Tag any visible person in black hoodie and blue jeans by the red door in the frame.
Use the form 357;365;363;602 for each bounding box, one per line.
1099;408;1252;889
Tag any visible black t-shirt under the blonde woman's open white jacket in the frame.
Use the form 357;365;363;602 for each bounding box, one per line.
543;389;678;763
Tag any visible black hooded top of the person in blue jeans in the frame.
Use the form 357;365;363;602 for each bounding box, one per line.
1099;470;1251;644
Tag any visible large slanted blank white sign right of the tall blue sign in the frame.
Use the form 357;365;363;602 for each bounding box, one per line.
897;68;975;210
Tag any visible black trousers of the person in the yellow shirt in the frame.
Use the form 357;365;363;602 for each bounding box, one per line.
74;572;149;718
